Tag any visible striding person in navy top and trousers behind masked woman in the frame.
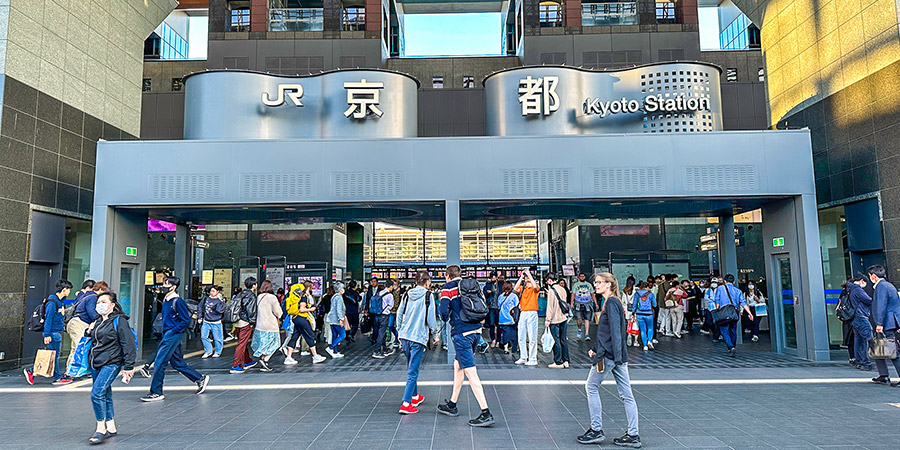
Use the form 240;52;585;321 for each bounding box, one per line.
141;277;209;402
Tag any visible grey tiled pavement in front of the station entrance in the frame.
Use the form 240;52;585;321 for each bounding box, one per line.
0;324;900;450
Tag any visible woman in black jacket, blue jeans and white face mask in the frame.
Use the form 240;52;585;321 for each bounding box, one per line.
85;292;137;444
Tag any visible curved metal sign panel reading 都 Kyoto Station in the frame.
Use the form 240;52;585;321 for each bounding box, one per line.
484;62;722;136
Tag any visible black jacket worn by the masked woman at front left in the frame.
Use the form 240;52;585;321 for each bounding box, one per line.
85;311;137;370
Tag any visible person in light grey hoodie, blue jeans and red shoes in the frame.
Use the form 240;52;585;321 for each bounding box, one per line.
397;270;440;414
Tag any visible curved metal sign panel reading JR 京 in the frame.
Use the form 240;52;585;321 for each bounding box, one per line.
184;70;418;139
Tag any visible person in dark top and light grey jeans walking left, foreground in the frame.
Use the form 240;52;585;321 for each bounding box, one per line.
577;272;641;448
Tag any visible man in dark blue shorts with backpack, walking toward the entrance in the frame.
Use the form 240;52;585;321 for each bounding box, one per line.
438;265;492;427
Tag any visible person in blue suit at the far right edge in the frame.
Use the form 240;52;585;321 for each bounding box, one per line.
866;264;900;387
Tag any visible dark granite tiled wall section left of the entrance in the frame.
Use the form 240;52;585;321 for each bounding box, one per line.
0;76;134;370
